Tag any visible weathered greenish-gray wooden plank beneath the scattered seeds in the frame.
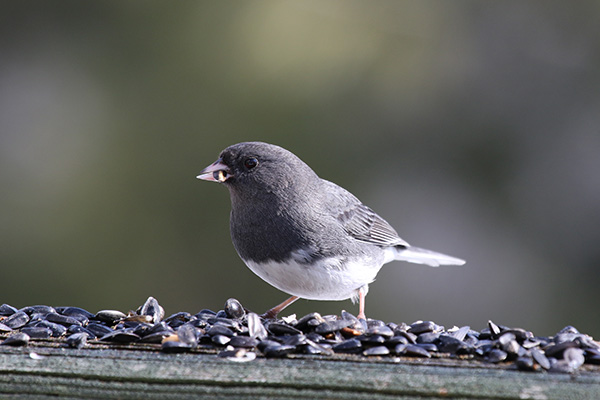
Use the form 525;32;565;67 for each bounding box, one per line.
0;347;600;400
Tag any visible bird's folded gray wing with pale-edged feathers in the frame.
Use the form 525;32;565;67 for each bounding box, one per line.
327;182;409;247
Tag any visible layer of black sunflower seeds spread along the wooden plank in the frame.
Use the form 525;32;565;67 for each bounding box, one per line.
0;297;600;373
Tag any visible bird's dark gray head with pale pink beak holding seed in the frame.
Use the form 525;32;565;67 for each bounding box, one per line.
198;142;318;202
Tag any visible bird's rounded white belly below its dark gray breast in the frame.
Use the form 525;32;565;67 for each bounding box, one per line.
246;258;381;300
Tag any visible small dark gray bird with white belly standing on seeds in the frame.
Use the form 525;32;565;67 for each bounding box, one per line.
198;142;465;319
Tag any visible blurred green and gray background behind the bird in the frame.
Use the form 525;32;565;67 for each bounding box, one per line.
0;0;600;336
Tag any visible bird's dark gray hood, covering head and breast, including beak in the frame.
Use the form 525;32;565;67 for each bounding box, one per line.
198;142;330;261
